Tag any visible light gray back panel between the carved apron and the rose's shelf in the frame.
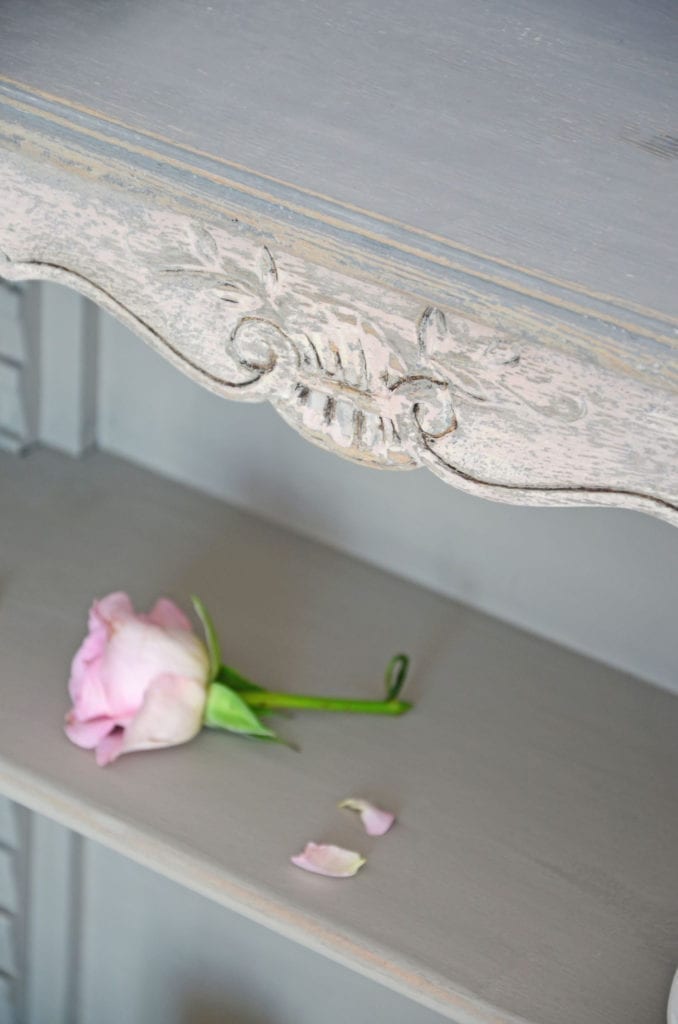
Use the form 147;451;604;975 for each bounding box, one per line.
97;303;678;690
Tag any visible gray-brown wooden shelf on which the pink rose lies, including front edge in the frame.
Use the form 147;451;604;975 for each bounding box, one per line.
0;452;678;1024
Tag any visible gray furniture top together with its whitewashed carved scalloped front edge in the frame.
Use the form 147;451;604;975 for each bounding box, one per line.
0;0;678;522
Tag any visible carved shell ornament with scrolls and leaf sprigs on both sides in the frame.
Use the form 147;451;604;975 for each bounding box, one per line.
164;225;585;468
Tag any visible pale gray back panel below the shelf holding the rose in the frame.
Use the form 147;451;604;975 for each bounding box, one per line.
76;842;443;1024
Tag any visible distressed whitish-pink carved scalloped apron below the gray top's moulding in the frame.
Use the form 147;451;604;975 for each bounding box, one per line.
0;124;678;521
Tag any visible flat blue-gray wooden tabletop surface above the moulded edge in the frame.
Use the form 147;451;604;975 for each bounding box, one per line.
0;0;678;316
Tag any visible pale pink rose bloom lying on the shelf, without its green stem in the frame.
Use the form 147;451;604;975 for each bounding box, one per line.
66;593;210;765
